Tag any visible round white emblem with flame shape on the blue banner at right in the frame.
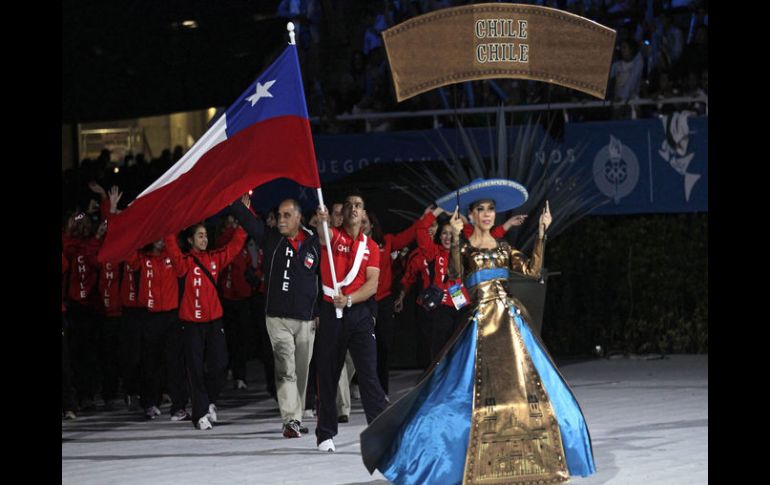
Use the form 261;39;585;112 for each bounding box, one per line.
593;135;639;204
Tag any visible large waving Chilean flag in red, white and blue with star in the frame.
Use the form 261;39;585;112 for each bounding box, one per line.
99;45;321;262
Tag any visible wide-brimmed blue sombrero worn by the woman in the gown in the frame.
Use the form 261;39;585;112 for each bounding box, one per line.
436;179;529;214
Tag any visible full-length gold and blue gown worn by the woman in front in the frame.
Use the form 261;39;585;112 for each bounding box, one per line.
361;233;596;485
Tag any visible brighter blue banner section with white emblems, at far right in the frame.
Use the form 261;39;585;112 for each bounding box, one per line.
565;113;708;214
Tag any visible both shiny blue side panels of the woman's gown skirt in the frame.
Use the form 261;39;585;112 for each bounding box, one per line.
377;306;596;485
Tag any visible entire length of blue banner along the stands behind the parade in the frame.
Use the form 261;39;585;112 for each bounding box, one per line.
249;112;708;214
